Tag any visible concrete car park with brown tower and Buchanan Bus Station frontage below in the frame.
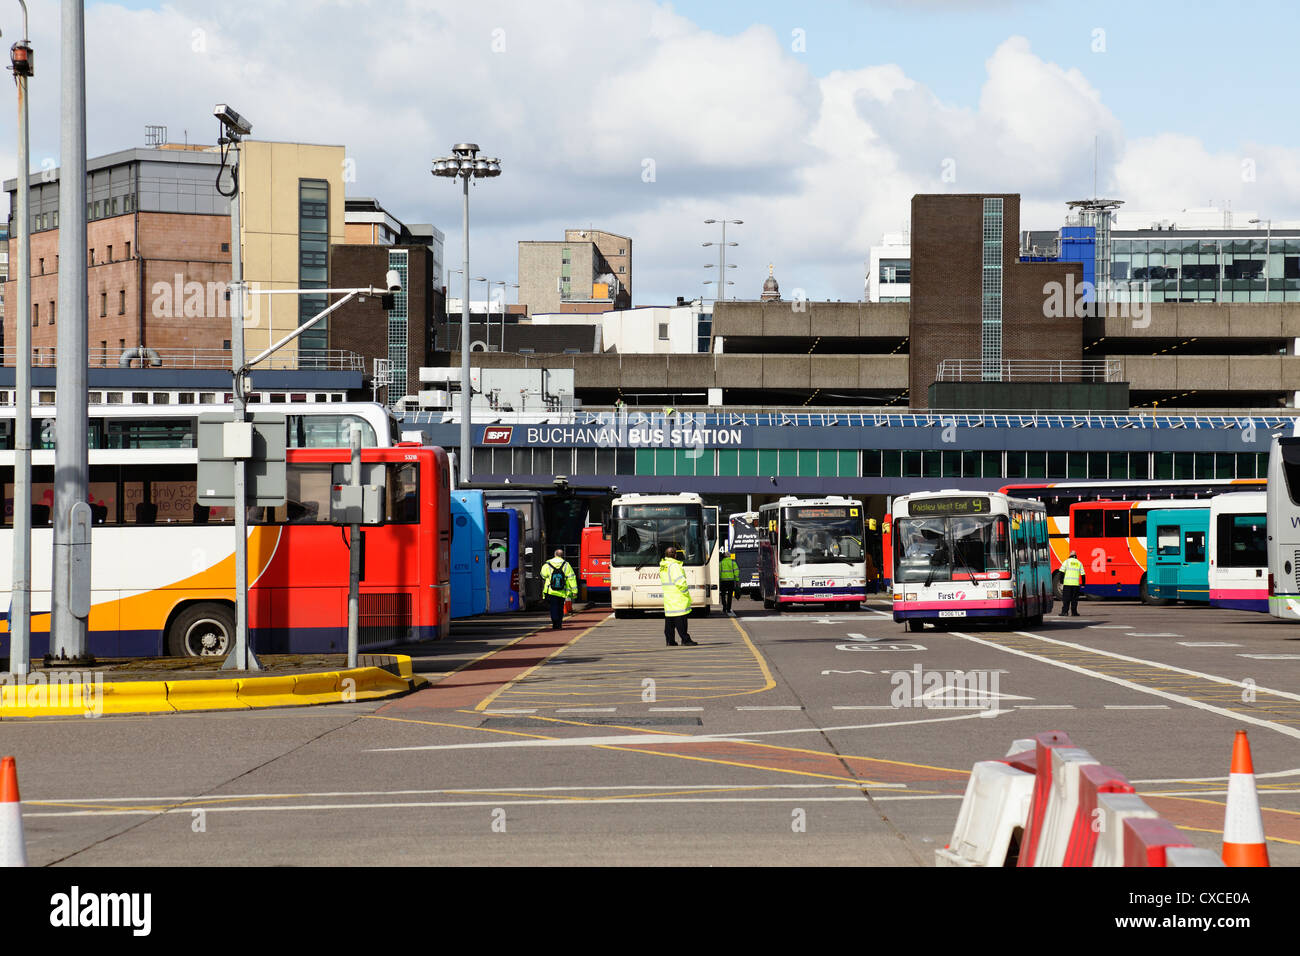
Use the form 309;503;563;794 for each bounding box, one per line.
407;194;1300;514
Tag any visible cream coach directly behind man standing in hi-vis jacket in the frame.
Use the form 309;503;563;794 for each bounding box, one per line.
605;493;720;618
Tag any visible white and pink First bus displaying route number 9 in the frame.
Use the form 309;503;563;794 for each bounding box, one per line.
893;490;1052;631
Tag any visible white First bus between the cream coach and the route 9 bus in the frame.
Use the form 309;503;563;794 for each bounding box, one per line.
758;497;867;610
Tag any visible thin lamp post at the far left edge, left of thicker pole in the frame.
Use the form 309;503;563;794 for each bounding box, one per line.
9;0;35;675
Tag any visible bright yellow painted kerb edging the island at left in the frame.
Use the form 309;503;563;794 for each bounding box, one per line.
0;654;416;719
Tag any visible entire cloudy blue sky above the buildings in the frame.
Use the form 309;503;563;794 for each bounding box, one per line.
12;0;1300;304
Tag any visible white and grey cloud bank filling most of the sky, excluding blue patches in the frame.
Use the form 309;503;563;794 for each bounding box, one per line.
0;0;1300;303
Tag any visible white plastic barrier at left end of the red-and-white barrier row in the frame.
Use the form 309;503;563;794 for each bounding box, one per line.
935;764;1034;866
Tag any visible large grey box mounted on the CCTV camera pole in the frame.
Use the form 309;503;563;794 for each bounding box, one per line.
196;412;287;507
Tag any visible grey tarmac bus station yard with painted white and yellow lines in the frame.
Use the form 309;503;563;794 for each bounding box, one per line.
0;601;1300;866
